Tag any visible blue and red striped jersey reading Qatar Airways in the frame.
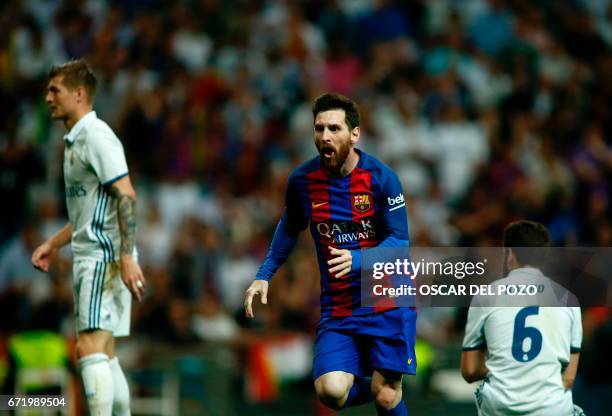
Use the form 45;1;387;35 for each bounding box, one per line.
256;149;409;317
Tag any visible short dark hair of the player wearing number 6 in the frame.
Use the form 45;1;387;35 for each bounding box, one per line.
504;220;550;266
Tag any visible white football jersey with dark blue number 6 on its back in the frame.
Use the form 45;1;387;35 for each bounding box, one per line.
463;267;582;416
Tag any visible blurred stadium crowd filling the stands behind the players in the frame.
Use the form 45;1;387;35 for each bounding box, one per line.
0;0;612;414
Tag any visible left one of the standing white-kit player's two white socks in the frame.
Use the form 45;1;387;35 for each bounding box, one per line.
79;353;114;416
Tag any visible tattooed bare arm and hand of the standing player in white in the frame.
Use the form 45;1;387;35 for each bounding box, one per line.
109;176;145;301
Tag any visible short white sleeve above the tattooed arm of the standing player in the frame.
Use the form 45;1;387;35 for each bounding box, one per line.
85;129;128;185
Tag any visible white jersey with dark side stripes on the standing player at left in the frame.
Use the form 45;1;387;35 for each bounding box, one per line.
64;111;128;262
